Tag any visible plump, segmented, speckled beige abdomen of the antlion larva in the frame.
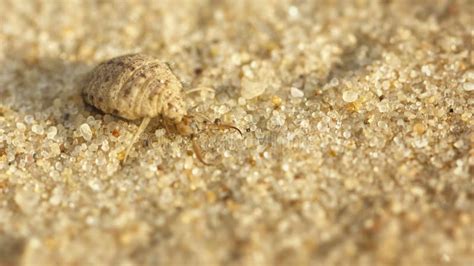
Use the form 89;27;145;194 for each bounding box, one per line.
82;54;184;120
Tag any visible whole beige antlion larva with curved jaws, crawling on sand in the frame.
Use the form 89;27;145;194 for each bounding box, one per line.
80;54;242;165
